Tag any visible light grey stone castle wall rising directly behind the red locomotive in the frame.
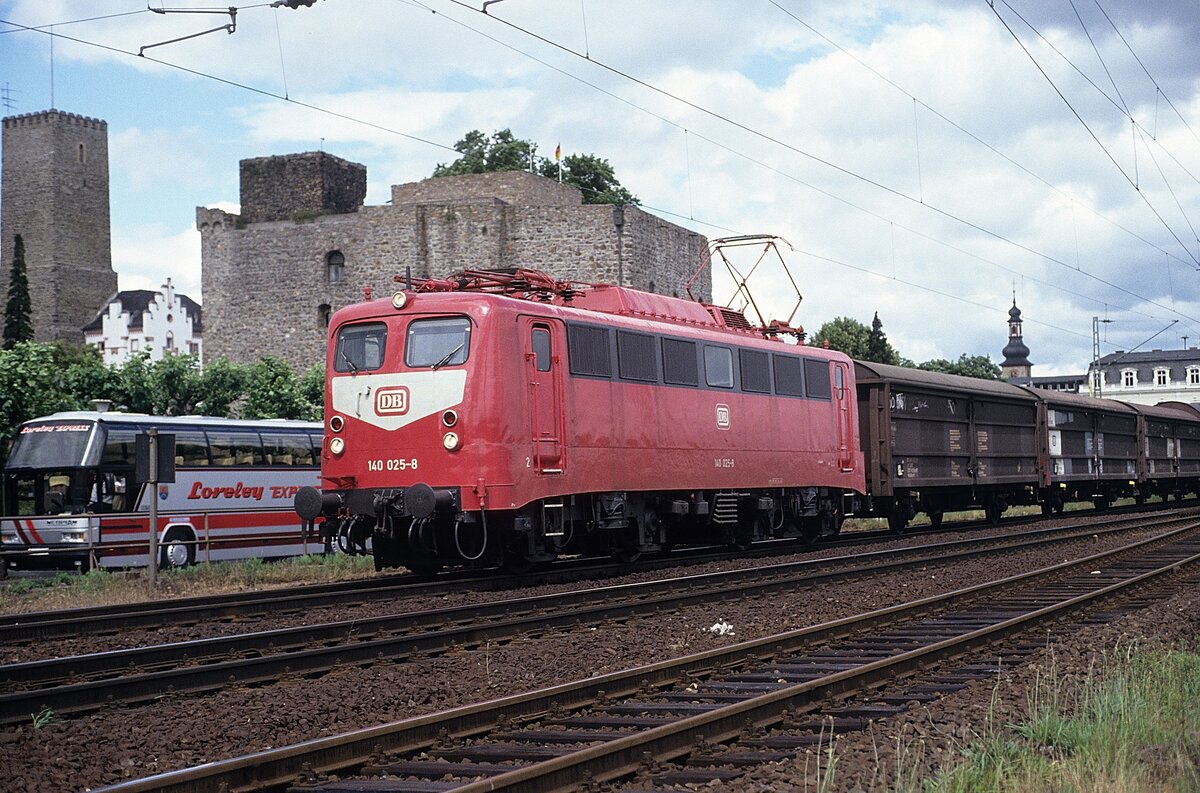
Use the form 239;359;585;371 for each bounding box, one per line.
197;160;710;370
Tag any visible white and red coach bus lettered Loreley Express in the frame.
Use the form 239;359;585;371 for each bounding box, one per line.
0;411;325;572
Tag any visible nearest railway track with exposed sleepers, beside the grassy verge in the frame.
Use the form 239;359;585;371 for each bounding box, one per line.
96;513;1200;793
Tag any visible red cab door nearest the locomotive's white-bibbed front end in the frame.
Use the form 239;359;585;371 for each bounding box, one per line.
522;317;566;474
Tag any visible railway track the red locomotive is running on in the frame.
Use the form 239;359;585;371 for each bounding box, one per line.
0;510;1166;647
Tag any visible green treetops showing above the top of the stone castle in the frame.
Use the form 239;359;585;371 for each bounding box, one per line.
433;130;638;204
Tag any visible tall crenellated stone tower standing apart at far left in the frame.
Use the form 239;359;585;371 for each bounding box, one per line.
0;110;116;343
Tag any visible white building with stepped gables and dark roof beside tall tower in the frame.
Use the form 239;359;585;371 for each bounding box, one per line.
83;278;204;365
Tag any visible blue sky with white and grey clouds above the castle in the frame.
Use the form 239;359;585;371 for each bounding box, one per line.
0;0;1200;374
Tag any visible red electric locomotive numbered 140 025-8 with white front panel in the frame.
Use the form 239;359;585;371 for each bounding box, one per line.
295;270;864;573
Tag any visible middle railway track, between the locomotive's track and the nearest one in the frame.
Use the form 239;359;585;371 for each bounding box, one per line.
0;515;1194;725
